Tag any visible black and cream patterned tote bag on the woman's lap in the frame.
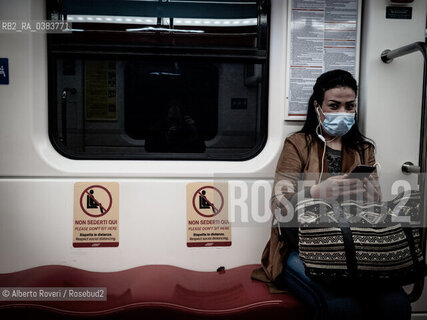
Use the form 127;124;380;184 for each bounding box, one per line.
295;191;426;285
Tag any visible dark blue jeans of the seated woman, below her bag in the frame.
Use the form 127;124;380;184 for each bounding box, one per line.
281;251;411;320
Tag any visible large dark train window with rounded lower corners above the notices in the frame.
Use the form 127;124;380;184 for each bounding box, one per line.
46;0;269;160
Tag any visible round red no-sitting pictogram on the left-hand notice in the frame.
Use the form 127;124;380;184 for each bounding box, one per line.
80;185;113;218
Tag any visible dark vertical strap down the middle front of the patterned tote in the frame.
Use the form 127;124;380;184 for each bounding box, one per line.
332;201;357;276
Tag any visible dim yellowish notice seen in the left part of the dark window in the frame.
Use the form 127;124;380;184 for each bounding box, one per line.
85;60;117;121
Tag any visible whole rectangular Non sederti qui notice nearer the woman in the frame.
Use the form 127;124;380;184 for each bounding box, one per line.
187;182;231;247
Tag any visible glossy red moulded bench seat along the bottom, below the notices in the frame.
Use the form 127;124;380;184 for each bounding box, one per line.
0;265;304;320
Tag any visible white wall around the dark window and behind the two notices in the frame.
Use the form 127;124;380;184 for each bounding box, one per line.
0;0;289;272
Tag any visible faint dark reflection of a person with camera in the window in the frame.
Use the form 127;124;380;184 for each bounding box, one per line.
145;100;205;152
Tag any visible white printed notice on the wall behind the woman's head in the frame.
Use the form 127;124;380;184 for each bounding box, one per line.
286;0;359;120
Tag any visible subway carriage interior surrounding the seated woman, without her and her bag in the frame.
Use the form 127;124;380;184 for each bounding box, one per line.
0;0;427;320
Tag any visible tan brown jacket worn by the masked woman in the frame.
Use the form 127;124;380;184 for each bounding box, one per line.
261;133;376;282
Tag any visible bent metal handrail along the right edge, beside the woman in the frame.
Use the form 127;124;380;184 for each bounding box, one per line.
381;42;427;302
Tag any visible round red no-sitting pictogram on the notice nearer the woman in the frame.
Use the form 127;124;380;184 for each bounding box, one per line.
192;186;224;218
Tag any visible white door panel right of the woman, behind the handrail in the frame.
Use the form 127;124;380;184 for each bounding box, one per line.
360;1;427;319
